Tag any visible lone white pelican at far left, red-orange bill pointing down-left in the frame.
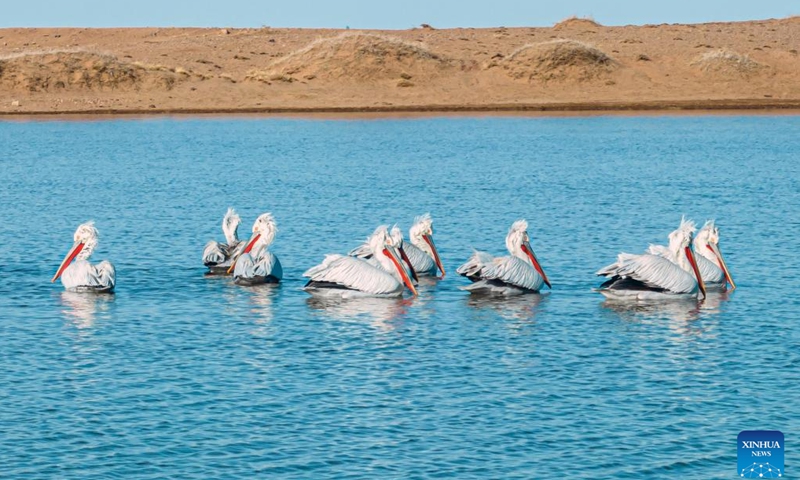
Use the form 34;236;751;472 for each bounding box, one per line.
50;221;117;293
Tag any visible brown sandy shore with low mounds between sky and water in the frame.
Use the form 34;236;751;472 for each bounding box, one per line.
0;17;800;116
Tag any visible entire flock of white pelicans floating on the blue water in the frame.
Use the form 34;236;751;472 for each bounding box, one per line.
51;212;736;310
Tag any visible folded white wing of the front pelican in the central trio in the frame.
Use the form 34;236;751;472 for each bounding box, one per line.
303;255;403;295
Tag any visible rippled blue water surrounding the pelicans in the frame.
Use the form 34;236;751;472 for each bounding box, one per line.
0;116;800;478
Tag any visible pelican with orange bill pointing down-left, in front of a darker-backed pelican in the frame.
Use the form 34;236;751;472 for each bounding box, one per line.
228;213;283;285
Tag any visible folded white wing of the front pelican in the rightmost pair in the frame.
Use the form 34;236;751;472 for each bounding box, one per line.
597;253;697;293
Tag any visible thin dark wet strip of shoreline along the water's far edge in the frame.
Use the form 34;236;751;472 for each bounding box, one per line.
0;99;800;121
